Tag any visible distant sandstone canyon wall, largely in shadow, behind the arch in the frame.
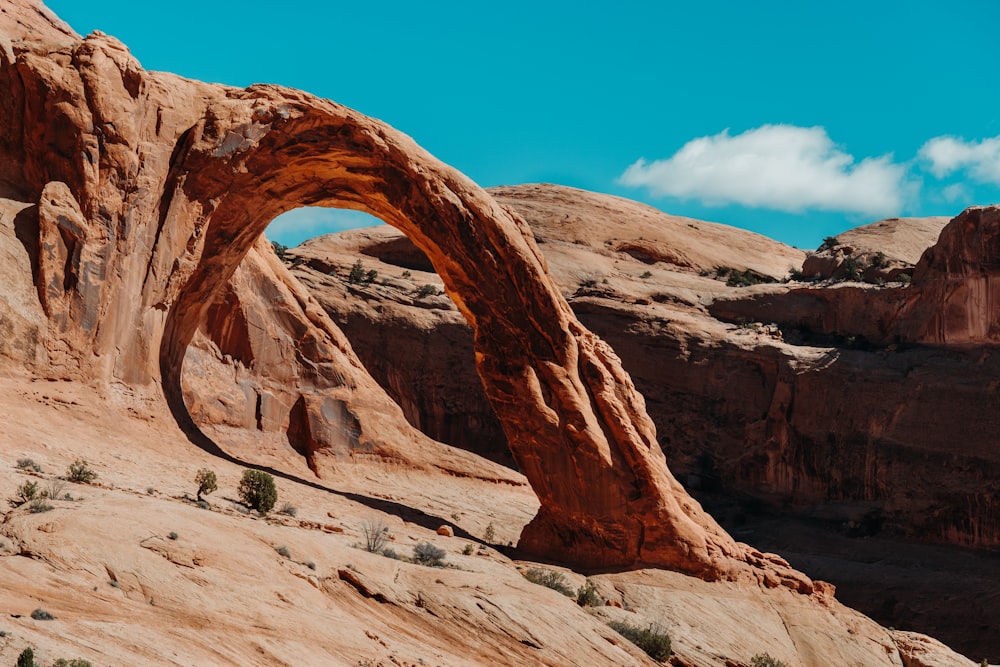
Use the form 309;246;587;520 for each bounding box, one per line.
291;185;1000;652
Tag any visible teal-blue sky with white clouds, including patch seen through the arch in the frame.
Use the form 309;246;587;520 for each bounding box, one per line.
47;0;1000;248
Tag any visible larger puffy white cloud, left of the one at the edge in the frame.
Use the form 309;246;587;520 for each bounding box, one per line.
619;125;916;216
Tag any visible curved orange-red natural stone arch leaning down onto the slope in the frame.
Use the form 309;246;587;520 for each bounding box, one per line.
160;86;742;578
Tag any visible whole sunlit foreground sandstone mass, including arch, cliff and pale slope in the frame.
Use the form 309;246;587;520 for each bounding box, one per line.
0;0;984;666
